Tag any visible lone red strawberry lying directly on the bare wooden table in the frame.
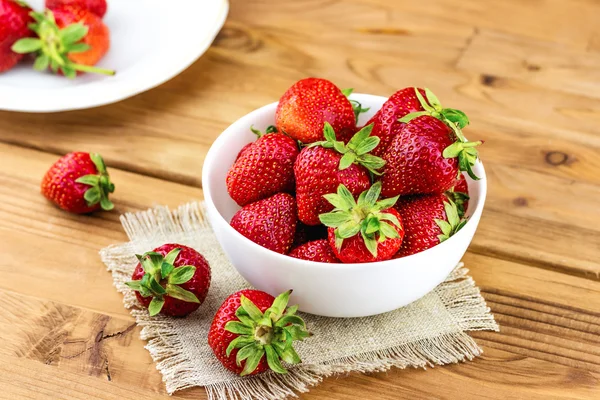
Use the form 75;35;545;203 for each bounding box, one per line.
42;152;115;214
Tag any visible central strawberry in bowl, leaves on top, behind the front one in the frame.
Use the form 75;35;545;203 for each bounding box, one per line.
294;122;383;225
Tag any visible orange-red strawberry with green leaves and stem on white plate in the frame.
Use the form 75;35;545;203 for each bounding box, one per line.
12;5;115;78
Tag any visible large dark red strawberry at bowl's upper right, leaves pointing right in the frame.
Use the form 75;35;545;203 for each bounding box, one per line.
381;89;482;196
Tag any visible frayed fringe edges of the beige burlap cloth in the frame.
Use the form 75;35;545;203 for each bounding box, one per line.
100;202;498;400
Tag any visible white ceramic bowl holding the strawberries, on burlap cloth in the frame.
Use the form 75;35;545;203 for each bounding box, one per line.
202;94;487;317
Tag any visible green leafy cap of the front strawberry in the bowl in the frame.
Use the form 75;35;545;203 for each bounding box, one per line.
319;182;402;257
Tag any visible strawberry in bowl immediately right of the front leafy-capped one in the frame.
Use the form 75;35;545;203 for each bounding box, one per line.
394;194;466;258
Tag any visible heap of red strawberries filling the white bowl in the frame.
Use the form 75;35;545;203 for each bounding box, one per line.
226;78;482;263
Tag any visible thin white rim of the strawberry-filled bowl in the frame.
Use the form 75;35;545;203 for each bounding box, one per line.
202;93;487;270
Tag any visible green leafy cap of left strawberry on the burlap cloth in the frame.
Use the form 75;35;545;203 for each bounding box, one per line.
125;248;200;317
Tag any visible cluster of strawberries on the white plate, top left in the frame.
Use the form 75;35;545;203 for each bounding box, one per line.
0;0;115;78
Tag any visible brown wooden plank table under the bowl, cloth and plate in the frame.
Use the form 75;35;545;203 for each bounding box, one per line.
0;0;600;399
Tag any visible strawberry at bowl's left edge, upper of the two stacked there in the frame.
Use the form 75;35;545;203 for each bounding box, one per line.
226;128;299;206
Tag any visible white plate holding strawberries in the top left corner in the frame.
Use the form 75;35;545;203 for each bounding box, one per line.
0;0;229;112
